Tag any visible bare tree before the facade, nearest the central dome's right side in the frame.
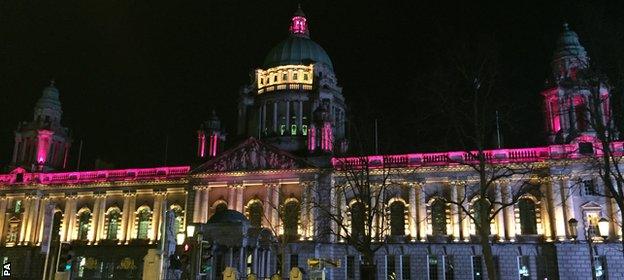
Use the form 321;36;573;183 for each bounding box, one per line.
313;157;394;279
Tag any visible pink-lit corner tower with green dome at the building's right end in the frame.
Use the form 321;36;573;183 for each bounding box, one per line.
542;23;612;144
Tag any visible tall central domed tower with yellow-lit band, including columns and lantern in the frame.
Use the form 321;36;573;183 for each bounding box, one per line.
238;7;346;152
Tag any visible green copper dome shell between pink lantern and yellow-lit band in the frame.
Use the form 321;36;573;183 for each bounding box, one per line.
264;35;334;70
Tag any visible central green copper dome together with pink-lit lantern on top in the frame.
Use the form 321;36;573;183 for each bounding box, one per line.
264;7;334;70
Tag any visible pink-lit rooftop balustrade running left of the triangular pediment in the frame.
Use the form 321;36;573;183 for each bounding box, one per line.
0;166;190;185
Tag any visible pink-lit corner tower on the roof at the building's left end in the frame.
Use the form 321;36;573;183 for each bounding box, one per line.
11;81;71;172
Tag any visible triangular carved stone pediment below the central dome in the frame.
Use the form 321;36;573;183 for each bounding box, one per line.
193;138;313;173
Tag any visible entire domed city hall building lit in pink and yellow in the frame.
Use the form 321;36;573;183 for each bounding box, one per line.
0;6;624;280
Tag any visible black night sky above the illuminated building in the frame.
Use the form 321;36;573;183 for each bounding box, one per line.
0;0;622;168
